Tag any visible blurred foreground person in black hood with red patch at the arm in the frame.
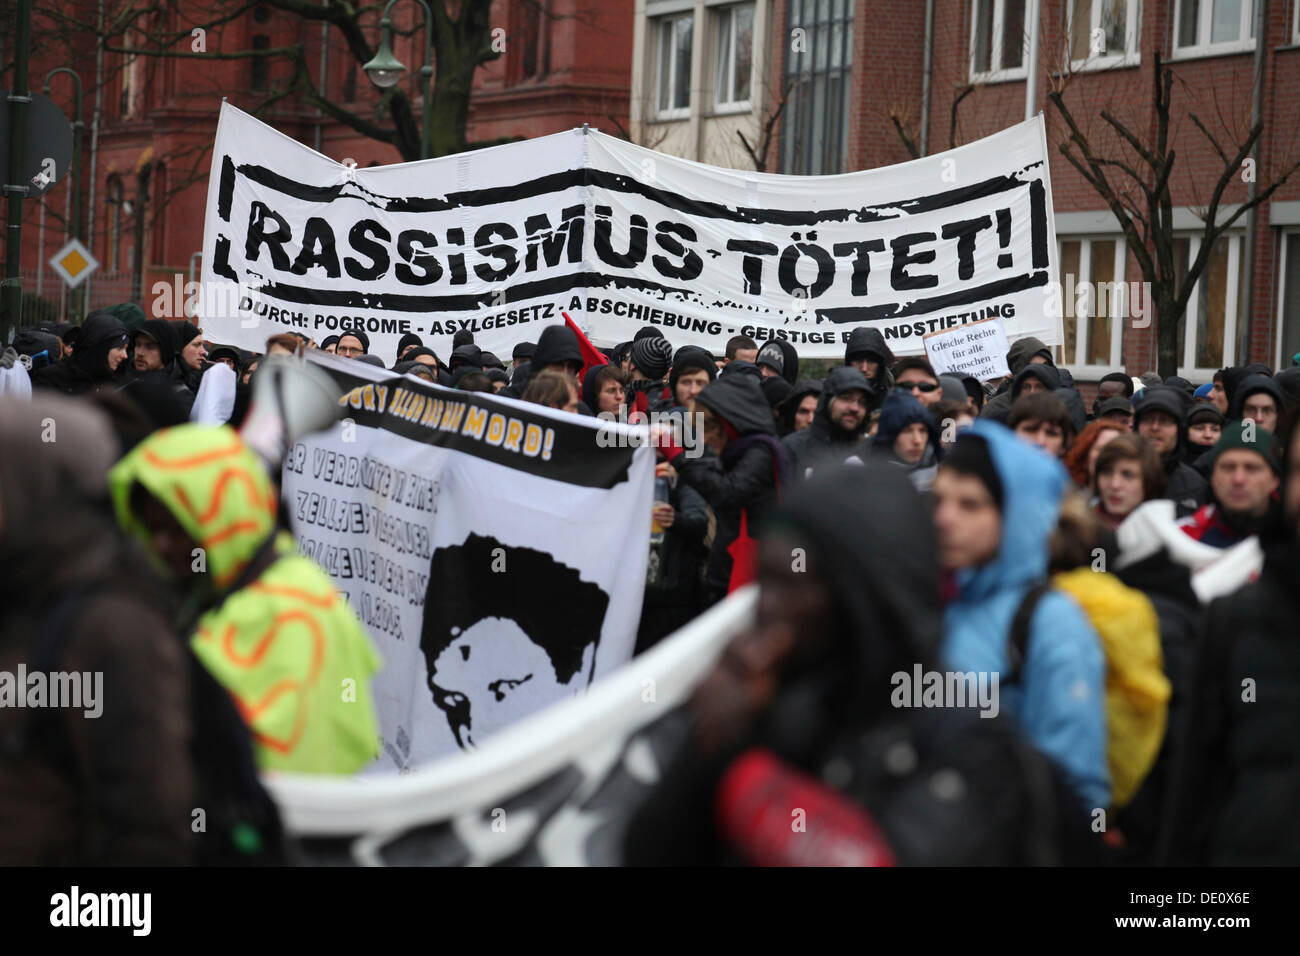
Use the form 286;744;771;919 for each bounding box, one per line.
623;463;1100;866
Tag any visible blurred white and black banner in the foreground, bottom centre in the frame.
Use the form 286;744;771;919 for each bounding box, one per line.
264;585;758;866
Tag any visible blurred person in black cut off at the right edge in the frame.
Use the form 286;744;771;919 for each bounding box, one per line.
1165;416;1300;866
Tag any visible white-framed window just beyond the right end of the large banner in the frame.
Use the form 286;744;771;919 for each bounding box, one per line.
1057;237;1130;377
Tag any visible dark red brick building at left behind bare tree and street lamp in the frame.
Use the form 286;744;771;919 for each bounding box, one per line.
12;0;632;325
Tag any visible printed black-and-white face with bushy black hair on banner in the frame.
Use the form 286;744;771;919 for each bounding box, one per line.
420;535;610;749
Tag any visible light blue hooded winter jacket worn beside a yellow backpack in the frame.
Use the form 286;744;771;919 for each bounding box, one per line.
943;419;1110;810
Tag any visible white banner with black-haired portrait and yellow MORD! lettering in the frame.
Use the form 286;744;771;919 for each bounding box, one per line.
283;354;654;770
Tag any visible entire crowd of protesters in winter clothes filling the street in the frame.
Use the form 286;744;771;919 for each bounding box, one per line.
0;304;1300;864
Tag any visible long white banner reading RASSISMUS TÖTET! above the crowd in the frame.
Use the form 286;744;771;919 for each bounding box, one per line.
197;104;1062;360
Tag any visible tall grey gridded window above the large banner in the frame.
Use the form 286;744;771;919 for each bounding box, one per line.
781;0;853;176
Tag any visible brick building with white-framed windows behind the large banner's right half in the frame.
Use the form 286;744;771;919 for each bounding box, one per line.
631;0;1300;382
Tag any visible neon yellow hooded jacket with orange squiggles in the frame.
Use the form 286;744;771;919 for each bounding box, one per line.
108;425;380;774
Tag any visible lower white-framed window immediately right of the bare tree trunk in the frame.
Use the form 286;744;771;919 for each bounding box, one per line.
1174;233;1244;381
